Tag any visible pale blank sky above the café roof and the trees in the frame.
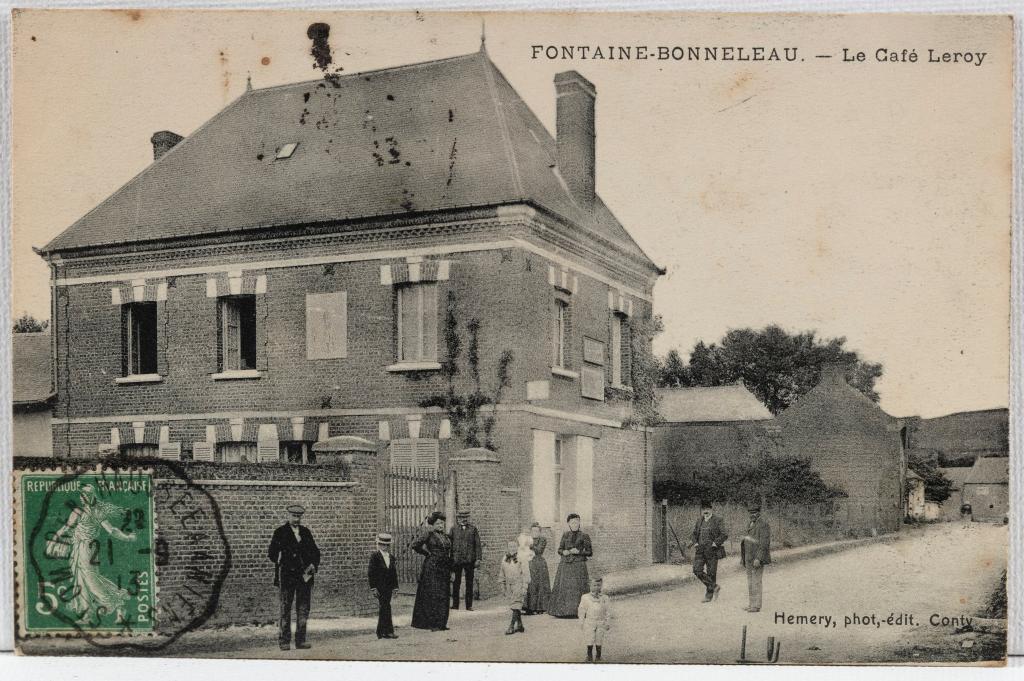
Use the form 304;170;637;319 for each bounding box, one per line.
12;10;1013;417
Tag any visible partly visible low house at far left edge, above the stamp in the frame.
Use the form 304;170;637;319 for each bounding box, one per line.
11;333;56;457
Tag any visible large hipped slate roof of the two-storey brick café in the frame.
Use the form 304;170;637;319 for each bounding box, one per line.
43;51;654;268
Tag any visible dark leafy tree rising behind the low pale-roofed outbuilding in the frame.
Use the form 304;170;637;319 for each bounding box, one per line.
660;325;882;414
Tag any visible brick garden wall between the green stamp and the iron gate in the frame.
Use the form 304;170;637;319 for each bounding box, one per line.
15;456;378;630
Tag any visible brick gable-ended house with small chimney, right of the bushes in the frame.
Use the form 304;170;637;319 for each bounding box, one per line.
775;366;907;534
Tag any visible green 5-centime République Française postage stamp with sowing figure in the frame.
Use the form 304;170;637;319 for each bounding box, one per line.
15;470;157;636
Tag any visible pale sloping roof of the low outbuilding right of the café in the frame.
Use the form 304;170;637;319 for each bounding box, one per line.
657;384;772;423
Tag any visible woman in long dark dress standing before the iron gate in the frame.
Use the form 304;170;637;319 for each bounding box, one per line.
412;511;452;631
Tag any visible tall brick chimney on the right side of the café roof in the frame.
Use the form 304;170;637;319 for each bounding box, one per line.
555;71;597;211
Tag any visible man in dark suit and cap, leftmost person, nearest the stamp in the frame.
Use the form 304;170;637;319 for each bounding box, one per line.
267;504;319;650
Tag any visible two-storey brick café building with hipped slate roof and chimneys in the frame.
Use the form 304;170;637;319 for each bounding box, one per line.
34;50;662;610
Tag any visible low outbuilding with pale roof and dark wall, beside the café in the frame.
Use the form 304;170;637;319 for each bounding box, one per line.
653;384;774;482
